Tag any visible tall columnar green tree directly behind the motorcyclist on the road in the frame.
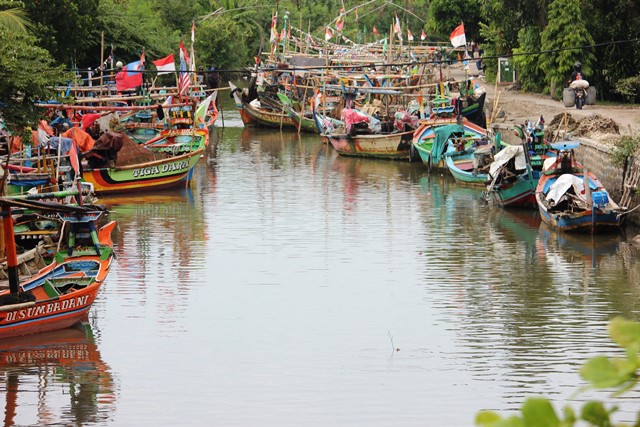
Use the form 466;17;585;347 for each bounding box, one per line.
541;0;595;96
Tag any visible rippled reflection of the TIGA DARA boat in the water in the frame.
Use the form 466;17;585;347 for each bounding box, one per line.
104;190;208;322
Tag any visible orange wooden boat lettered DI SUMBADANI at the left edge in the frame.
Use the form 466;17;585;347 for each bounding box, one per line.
0;195;115;339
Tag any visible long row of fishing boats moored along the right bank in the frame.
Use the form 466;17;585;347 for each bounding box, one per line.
230;50;623;237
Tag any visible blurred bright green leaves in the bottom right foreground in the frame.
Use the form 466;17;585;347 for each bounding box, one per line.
476;317;640;427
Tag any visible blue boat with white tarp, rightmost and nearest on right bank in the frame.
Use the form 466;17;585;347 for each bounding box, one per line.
536;141;621;233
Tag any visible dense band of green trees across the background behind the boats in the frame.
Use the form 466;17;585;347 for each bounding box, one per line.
0;0;640;106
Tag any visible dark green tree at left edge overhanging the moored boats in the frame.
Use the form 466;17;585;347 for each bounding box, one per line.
0;30;70;134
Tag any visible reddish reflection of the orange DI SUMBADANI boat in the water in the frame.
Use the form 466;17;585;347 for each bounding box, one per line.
0;324;116;426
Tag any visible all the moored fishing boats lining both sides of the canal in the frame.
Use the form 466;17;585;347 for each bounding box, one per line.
0;29;621;339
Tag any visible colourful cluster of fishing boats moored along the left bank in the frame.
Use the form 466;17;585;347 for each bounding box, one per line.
0;61;218;339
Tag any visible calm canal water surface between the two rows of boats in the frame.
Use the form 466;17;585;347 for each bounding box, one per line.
0;104;640;427
